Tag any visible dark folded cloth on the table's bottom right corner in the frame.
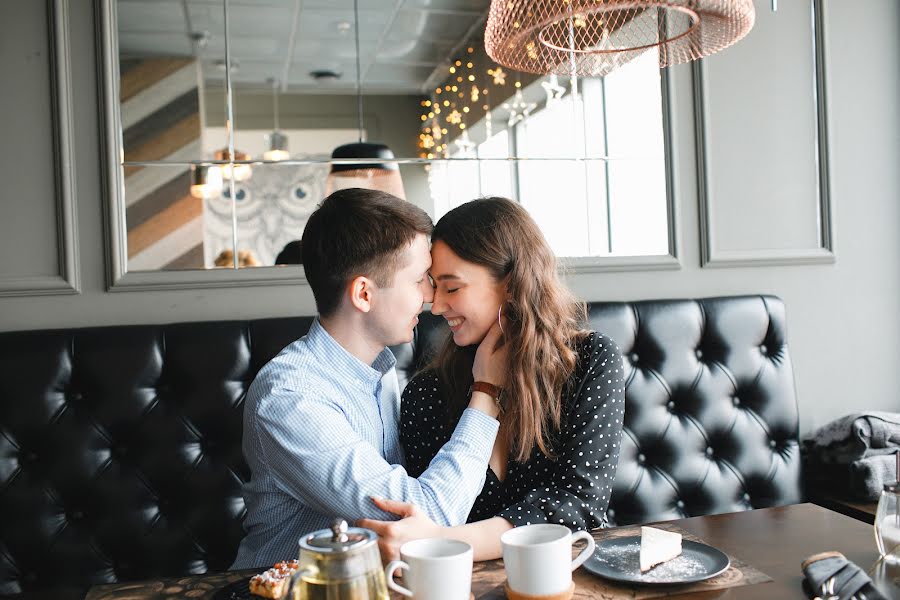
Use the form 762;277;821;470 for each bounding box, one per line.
802;552;887;600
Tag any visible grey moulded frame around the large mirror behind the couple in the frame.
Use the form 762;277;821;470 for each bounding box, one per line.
95;0;681;292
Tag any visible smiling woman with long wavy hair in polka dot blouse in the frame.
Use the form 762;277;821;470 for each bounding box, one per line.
360;198;625;560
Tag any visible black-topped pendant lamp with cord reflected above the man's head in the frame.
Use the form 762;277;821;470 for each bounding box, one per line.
326;0;406;200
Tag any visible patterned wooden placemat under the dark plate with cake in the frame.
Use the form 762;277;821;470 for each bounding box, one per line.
472;523;772;600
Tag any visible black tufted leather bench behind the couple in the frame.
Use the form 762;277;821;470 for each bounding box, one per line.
0;296;802;597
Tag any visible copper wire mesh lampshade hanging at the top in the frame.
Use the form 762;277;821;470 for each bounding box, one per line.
484;0;756;77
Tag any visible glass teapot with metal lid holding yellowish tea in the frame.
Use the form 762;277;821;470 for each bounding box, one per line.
285;519;389;600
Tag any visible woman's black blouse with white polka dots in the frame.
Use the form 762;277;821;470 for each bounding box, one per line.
400;332;625;530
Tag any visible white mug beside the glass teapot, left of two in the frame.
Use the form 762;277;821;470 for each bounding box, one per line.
384;538;472;600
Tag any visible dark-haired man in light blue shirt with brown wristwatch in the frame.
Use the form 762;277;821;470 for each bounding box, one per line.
232;189;499;569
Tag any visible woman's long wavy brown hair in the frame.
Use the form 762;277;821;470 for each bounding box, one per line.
429;198;586;462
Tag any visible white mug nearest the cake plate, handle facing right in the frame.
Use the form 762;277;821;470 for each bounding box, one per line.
500;524;597;596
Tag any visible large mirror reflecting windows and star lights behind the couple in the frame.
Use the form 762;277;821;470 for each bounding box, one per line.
102;0;677;287
